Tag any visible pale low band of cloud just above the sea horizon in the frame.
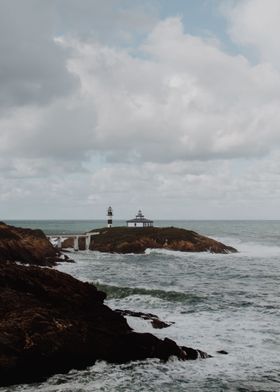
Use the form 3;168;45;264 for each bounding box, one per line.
3;154;280;219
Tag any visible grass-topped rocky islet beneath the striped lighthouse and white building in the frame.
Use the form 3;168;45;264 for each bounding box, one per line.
62;227;237;253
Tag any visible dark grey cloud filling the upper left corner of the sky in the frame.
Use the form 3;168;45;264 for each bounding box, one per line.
0;0;78;109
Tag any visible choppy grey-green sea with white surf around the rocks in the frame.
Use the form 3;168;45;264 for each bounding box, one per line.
0;220;280;392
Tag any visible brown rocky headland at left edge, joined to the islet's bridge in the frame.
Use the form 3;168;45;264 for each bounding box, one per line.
0;222;61;265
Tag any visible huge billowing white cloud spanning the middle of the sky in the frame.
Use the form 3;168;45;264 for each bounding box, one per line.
0;18;280;168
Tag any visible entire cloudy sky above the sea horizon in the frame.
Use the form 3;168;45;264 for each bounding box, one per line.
0;0;280;220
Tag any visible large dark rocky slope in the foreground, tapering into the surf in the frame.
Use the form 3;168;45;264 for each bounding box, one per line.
0;262;210;386
